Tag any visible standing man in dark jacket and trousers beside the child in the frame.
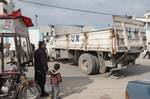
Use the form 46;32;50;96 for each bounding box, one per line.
34;41;48;97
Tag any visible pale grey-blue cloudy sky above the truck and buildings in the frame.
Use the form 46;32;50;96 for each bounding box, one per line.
13;0;150;26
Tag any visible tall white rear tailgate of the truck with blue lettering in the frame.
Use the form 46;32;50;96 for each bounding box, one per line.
113;16;145;50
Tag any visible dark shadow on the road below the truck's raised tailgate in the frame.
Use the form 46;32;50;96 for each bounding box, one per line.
110;64;150;79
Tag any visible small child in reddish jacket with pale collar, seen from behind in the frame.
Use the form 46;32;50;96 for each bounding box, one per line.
50;64;62;99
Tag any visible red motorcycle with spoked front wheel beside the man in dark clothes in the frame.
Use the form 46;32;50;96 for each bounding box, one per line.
0;62;41;99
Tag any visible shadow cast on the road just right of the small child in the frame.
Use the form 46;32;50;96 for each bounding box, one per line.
60;77;93;98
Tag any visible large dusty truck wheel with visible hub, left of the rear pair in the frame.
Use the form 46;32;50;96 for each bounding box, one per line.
78;54;96;75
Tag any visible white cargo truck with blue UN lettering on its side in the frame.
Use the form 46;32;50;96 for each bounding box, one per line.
53;16;144;74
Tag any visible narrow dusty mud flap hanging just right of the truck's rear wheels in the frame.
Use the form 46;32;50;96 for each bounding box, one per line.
99;55;107;74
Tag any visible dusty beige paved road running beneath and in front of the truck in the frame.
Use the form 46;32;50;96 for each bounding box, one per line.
25;53;150;99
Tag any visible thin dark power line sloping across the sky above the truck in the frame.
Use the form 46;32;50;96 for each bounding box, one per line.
18;0;115;16
